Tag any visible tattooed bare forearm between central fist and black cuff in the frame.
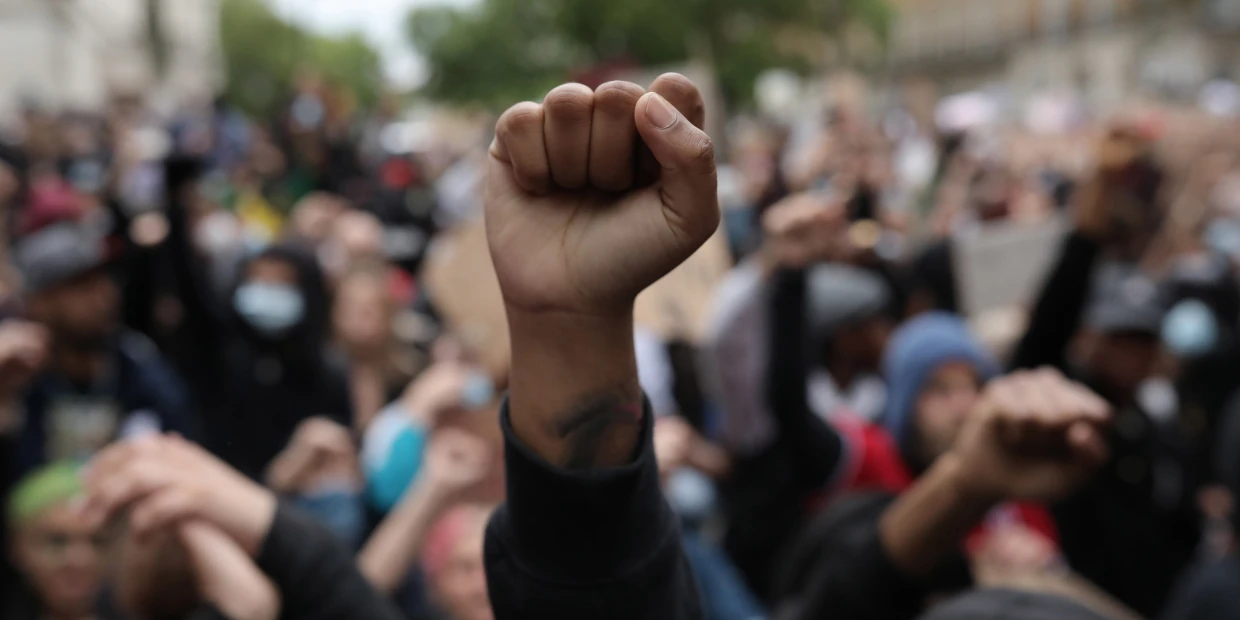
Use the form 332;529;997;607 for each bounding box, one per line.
508;308;642;470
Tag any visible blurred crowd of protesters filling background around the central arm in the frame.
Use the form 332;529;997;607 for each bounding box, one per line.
0;67;1240;620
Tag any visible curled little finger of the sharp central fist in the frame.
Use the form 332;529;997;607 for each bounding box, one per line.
491;102;552;193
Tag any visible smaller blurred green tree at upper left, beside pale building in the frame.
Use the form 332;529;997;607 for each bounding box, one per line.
219;0;383;115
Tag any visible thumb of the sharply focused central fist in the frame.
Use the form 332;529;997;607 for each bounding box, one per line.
634;93;719;242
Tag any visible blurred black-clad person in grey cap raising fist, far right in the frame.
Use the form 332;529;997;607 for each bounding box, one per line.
1013;133;1200;615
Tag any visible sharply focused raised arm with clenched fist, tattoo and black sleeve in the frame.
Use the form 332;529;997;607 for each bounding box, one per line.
486;74;719;620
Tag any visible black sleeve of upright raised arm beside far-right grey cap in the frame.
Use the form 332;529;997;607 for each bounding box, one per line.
1012;232;1101;370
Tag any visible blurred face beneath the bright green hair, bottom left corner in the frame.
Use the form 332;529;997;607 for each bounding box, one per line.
14;502;105;618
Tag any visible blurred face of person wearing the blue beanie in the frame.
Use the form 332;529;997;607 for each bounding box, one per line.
914;362;980;465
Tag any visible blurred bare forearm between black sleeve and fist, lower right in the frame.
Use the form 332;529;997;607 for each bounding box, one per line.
879;455;996;578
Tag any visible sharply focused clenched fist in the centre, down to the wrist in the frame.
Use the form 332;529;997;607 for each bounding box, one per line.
486;74;719;315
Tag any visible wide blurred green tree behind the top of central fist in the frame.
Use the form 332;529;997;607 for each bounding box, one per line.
408;0;892;105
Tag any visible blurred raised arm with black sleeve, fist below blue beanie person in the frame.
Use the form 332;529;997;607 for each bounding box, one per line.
776;370;1110;620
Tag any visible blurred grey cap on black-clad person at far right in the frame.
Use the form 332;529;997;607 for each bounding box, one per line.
1085;263;1167;335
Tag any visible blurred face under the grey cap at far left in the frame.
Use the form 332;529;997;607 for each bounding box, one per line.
31;270;120;348
